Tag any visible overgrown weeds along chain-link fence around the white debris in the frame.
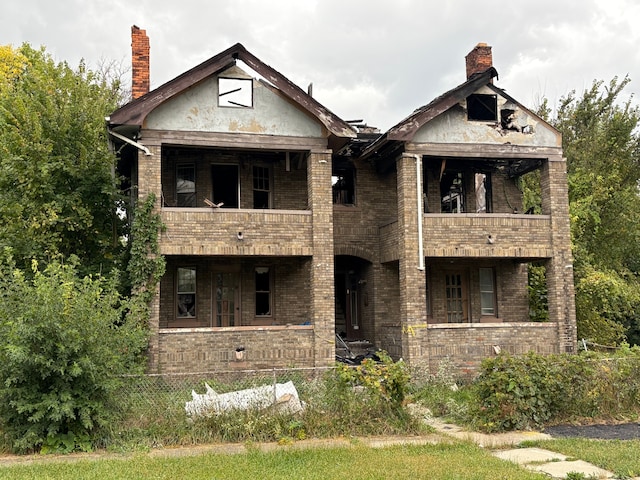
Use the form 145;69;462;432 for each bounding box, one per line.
95;369;429;452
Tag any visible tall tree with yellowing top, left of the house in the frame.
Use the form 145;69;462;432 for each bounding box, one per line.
0;44;123;278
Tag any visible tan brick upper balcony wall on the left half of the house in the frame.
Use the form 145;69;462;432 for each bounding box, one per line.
160;207;313;256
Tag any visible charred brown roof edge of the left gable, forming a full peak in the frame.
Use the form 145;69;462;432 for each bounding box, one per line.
108;43;356;138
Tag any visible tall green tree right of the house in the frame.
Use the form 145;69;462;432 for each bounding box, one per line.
540;78;640;344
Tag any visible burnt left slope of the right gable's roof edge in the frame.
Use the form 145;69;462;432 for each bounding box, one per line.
362;67;498;157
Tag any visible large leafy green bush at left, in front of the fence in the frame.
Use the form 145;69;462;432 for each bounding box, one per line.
0;260;147;452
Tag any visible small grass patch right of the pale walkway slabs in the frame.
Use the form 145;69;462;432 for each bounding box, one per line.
526;438;640;478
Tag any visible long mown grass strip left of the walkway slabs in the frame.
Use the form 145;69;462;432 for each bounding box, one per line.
0;443;547;480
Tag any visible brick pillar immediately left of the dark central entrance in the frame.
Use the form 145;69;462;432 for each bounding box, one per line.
307;150;335;366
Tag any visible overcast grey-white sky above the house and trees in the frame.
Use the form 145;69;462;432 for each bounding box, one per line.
0;0;640;129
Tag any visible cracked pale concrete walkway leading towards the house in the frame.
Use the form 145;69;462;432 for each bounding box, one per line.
428;419;640;480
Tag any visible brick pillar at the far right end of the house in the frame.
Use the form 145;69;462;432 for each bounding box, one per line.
541;155;577;352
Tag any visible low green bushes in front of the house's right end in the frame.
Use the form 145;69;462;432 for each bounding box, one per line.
472;345;640;431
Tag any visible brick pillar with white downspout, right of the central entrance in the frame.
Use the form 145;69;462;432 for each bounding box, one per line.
396;154;427;362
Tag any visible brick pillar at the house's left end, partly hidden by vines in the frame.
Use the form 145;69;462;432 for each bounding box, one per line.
136;139;162;372
